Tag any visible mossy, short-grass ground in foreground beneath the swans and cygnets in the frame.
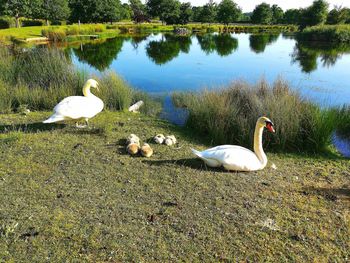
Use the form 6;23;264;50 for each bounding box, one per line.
0;112;350;262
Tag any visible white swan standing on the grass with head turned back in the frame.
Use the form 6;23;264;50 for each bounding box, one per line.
43;79;104;128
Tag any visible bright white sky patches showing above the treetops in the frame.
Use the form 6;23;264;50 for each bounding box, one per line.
122;0;350;12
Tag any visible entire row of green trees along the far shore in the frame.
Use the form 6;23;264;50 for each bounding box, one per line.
0;0;350;28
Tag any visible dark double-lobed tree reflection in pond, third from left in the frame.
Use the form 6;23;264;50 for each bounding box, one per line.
197;34;238;57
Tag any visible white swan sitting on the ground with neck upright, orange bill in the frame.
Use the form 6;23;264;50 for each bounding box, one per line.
192;117;275;172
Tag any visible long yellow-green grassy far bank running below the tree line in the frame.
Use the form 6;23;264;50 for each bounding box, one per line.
0;23;298;44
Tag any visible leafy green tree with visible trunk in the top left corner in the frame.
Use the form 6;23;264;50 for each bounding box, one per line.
0;0;41;27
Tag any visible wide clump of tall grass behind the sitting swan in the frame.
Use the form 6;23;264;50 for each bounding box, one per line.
173;80;350;153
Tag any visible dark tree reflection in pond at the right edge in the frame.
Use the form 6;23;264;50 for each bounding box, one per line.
292;41;350;73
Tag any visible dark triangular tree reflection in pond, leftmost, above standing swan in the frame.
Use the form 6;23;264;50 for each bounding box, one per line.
72;37;125;71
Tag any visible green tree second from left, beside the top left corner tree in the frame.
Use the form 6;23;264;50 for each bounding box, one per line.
38;0;70;25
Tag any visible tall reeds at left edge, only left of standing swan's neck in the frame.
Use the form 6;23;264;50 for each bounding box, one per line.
0;48;84;112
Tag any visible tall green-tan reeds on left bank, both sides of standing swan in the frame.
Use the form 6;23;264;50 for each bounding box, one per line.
0;48;161;115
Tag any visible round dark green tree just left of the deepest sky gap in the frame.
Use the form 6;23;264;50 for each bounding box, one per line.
217;0;242;25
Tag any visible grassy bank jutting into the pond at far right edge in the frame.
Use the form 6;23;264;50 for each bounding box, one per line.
298;25;350;43
